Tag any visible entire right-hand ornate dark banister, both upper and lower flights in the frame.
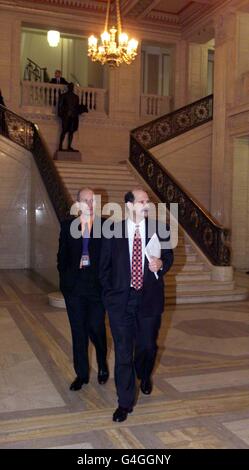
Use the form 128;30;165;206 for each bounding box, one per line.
130;95;231;266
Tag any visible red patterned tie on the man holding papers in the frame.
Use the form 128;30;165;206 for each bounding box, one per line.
131;225;143;290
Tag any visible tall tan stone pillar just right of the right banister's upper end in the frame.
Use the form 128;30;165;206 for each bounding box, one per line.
211;12;236;224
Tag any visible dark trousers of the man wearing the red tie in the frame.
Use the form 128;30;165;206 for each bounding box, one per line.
110;288;161;408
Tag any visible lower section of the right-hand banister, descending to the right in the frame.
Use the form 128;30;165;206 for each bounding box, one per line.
130;136;231;266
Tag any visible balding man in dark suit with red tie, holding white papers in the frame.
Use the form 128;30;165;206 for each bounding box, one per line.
100;189;173;422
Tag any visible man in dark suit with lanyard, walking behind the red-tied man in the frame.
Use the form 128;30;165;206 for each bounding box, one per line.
57;188;109;390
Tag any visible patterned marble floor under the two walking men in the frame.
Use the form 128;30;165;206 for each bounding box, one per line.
0;270;249;449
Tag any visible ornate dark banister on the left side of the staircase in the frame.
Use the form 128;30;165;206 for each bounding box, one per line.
0;105;73;222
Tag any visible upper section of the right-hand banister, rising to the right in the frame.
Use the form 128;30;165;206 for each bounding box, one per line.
132;95;213;149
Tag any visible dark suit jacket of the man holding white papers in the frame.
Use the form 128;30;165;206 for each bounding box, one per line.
100;220;174;318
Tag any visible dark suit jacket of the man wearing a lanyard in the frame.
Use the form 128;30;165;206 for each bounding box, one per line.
57;217;104;295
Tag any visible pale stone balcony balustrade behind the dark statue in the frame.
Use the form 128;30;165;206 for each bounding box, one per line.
21;80;106;114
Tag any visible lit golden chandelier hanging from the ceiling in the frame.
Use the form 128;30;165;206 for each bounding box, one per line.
88;0;138;67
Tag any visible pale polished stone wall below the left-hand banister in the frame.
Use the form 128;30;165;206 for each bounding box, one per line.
0;136;59;286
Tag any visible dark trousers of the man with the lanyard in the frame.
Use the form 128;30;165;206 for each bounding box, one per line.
64;293;107;381
